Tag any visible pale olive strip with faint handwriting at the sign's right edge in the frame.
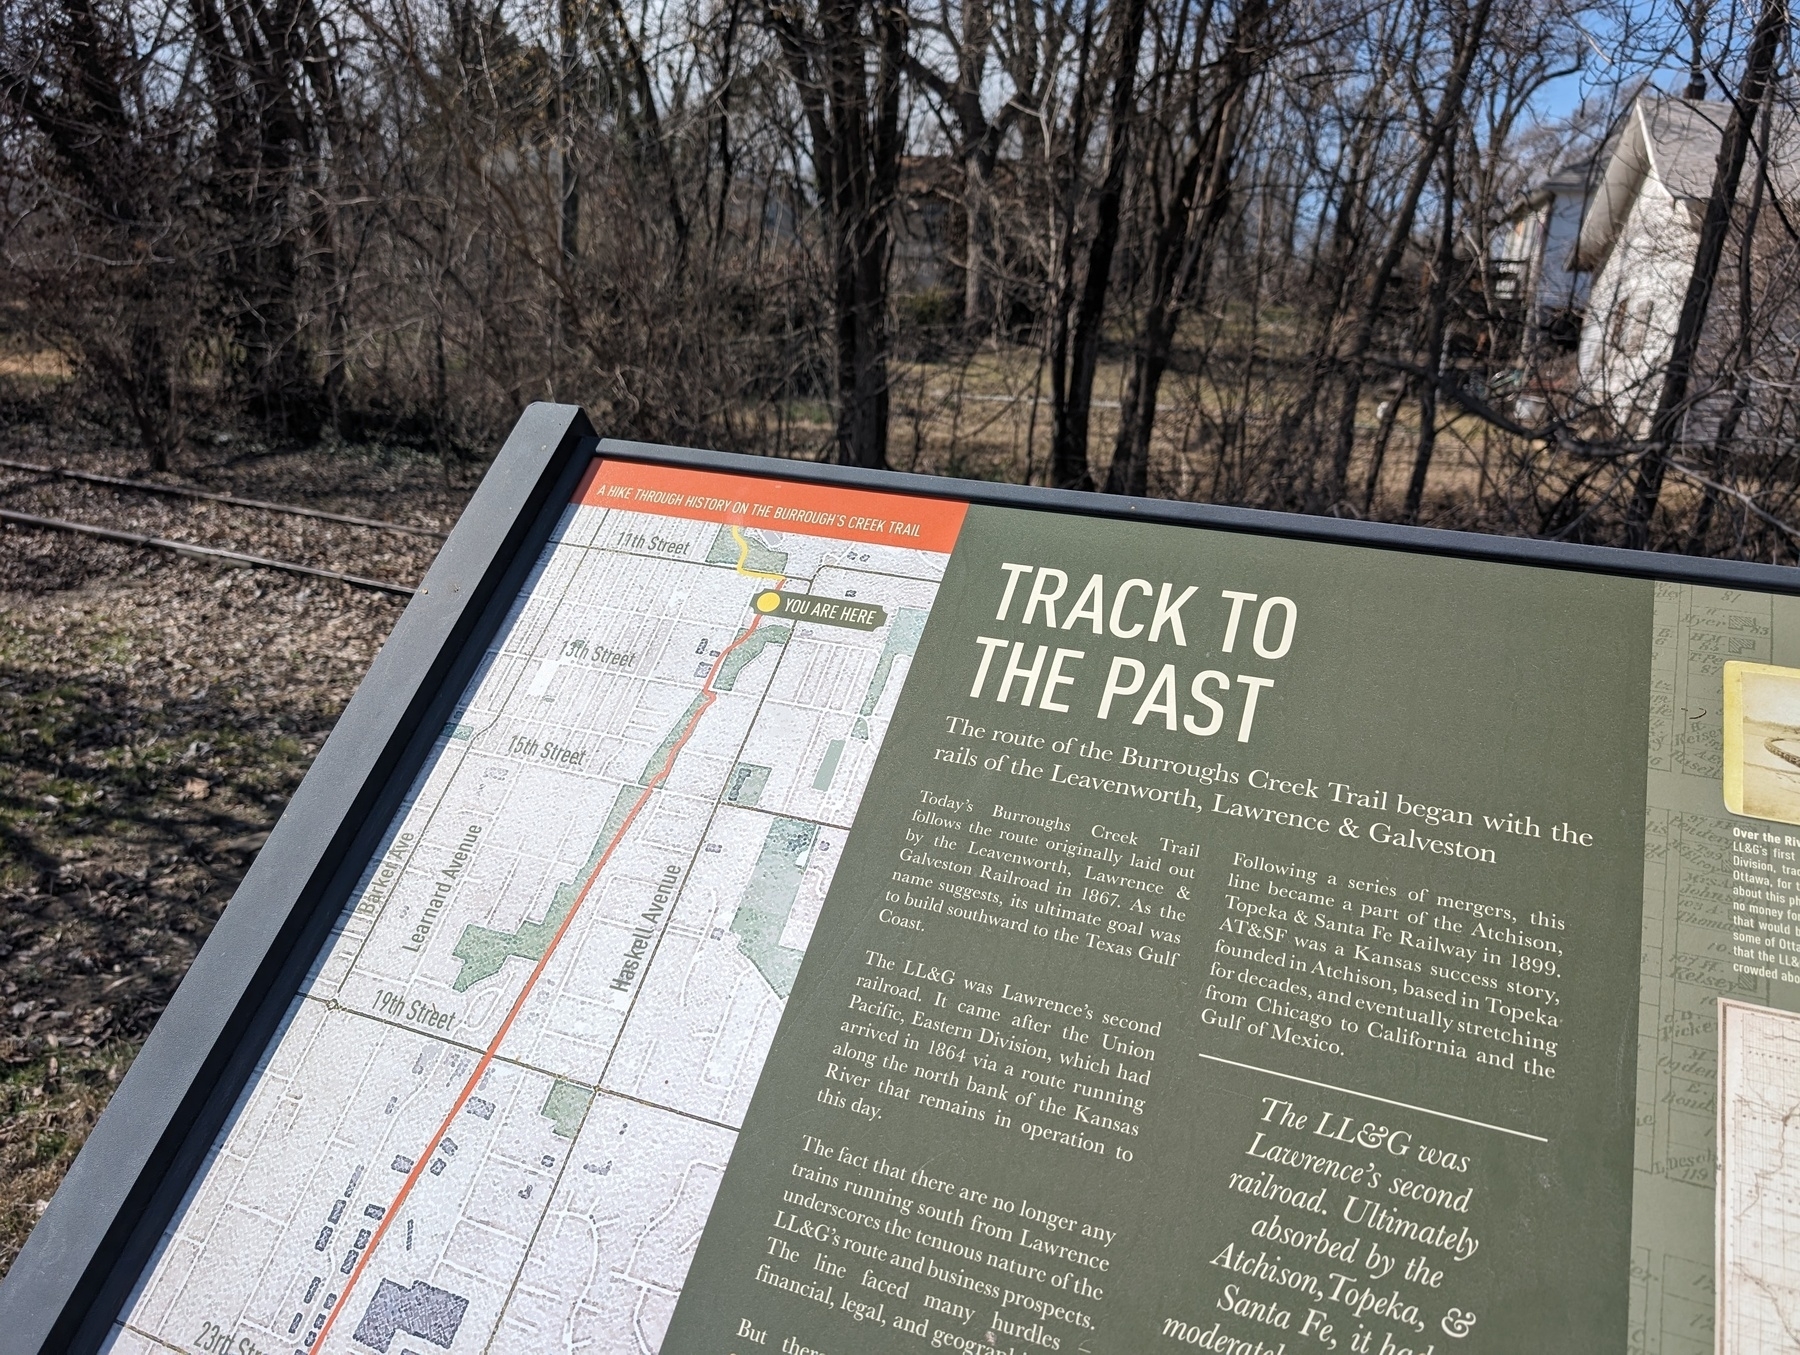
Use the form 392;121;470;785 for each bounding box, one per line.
1631;583;1800;1355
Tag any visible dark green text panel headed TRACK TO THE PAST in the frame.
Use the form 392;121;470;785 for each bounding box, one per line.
664;507;1654;1351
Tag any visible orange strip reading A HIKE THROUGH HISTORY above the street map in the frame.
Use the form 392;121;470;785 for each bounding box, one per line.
574;459;968;554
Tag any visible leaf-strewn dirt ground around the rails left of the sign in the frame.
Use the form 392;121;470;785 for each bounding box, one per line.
0;412;479;1274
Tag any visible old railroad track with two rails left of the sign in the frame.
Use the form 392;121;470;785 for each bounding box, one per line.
0;457;446;597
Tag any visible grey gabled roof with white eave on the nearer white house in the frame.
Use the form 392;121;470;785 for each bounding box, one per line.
1573;94;1732;272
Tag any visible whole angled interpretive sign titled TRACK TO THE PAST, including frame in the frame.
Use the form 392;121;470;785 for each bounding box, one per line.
10;407;1800;1355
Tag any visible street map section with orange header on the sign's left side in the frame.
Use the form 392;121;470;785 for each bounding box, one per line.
110;461;963;1355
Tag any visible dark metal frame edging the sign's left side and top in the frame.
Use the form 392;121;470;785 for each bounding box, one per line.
0;403;1800;1355
